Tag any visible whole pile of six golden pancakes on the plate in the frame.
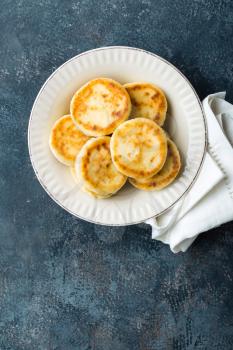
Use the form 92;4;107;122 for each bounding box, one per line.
49;78;181;198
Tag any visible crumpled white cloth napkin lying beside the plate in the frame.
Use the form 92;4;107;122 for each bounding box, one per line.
146;92;233;253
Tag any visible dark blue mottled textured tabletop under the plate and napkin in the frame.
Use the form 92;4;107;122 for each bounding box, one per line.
0;0;233;350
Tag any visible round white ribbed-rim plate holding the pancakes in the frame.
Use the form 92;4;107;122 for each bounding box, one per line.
28;46;206;225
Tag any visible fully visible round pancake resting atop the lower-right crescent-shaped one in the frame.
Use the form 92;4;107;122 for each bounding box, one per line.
111;118;167;178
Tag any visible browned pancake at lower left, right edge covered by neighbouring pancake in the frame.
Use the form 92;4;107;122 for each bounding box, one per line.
76;136;127;195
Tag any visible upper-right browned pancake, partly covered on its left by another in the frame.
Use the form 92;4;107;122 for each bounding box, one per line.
124;82;167;126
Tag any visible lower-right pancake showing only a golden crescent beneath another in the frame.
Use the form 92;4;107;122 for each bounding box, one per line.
129;139;181;191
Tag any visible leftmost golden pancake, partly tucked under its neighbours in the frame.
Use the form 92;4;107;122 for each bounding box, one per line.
49;115;89;165
